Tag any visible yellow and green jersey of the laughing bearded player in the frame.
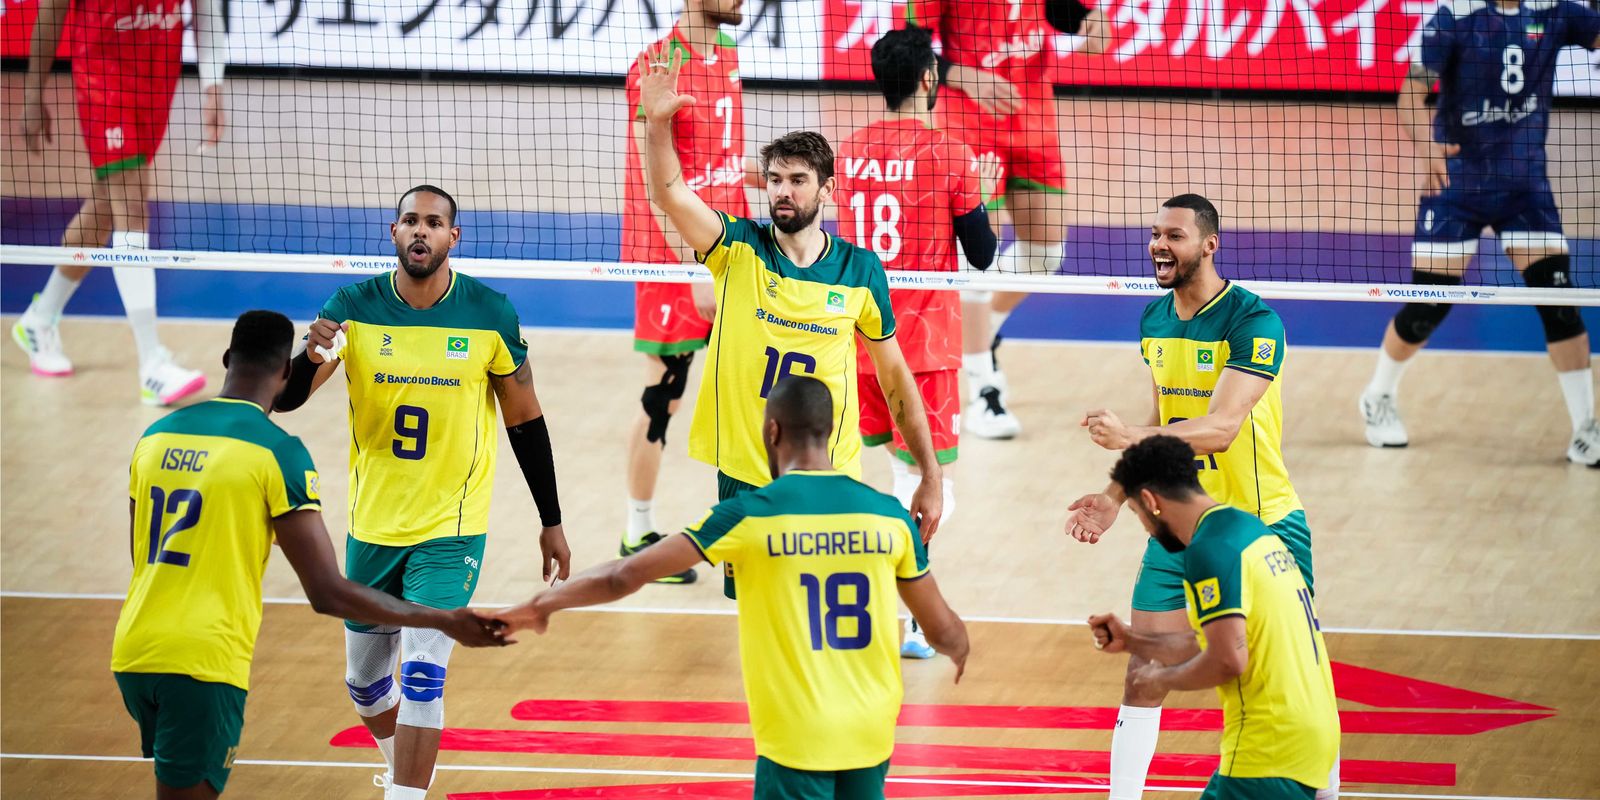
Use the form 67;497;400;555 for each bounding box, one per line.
1139;283;1301;525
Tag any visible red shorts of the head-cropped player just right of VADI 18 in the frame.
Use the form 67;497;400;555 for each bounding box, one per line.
934;91;1067;194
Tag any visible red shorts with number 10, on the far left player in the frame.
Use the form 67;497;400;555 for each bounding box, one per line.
72;27;184;179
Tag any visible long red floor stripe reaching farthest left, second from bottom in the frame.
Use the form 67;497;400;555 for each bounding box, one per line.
330;726;1456;786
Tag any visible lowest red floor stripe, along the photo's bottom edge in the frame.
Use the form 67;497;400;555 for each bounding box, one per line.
450;773;1205;800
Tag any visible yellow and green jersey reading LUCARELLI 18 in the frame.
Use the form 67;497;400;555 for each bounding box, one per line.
686;472;928;771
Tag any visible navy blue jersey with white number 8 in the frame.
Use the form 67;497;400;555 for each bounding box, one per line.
1421;0;1600;192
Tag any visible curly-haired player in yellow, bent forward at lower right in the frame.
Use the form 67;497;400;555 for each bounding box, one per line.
1090;435;1339;800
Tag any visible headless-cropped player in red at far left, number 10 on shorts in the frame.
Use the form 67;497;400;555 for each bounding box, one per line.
11;0;227;405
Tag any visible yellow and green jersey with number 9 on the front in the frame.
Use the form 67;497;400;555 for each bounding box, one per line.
320;272;528;547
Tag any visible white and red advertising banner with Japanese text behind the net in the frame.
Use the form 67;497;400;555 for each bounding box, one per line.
0;0;1600;96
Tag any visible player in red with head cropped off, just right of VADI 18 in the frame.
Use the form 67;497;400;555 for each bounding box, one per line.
906;0;1107;438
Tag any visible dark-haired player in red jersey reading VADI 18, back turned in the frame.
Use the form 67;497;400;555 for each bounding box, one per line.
834;27;998;658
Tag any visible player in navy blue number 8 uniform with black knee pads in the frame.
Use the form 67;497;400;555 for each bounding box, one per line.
1360;0;1600;467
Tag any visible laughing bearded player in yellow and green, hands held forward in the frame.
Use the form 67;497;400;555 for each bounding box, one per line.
1067;194;1314;800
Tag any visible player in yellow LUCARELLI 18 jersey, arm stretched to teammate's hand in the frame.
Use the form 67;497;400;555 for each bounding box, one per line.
494;376;968;800
